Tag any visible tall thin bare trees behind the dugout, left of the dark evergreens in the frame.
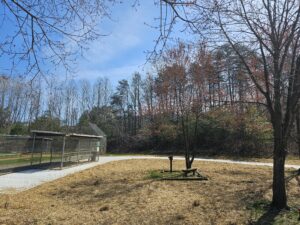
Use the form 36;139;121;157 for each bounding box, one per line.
0;75;112;134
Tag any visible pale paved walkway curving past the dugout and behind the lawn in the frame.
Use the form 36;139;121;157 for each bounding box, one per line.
0;156;300;193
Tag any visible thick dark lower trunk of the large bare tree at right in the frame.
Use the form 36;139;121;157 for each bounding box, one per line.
272;124;287;209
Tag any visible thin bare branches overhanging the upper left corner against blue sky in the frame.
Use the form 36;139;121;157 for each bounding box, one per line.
0;0;114;77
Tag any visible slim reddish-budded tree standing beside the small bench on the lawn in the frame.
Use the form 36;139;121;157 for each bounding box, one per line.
156;43;199;169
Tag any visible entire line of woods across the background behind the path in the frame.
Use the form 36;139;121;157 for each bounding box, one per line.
0;43;300;156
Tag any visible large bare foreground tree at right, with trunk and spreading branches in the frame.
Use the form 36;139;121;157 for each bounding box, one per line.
161;0;300;209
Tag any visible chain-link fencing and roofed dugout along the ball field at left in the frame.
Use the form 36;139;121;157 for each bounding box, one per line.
0;134;106;173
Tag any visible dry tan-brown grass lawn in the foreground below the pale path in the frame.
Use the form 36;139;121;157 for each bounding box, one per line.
0;160;300;225
